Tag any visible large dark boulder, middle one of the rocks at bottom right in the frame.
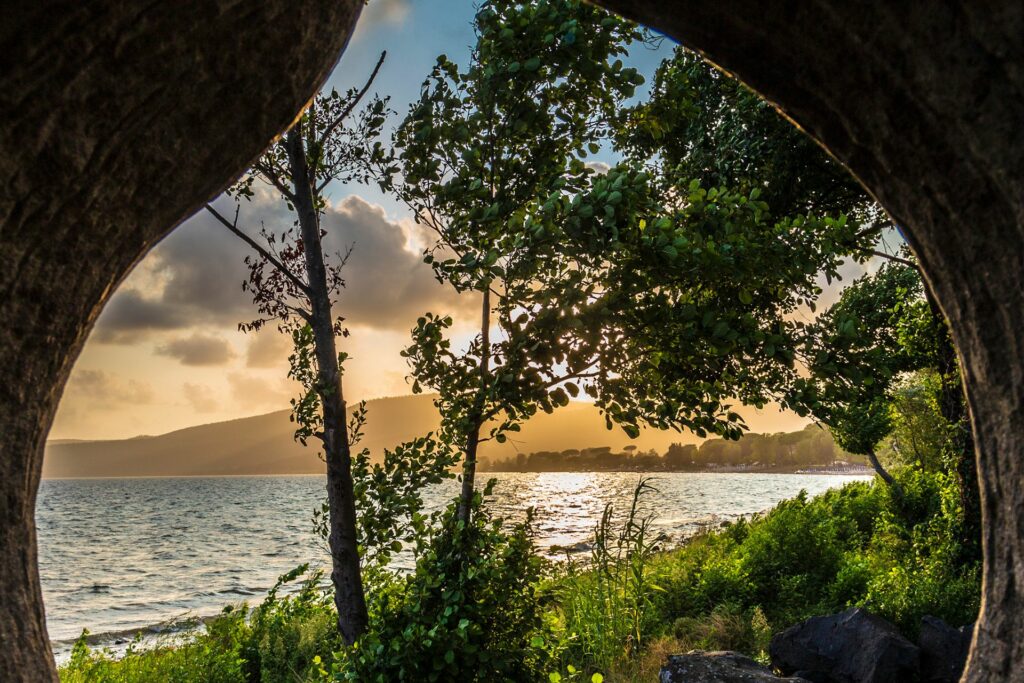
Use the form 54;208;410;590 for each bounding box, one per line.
768;607;919;683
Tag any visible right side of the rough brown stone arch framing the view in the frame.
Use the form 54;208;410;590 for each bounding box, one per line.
598;0;1024;683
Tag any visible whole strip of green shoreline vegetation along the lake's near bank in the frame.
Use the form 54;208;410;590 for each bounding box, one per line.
61;467;981;683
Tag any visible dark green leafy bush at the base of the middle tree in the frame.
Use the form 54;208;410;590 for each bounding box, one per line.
336;482;546;682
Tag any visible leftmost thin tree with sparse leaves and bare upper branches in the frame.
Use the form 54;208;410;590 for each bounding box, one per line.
207;54;387;644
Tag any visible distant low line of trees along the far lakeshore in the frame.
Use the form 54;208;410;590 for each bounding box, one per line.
481;423;864;472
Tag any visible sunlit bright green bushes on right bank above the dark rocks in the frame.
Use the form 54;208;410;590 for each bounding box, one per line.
654;471;980;638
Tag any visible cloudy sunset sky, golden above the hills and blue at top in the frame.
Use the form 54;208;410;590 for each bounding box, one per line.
50;0;864;438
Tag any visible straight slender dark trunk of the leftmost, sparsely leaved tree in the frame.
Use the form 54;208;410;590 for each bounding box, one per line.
286;124;369;645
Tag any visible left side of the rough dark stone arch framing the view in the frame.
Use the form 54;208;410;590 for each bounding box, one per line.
0;0;362;683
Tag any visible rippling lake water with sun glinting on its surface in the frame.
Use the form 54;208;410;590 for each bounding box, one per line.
36;472;867;653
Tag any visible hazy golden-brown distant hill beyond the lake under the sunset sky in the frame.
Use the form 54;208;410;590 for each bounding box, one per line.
43;395;801;478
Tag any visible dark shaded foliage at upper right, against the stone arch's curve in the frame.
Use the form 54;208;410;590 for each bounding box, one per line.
616;46;889;236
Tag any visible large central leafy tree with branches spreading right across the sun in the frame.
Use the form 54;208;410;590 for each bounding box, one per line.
383;0;868;528
